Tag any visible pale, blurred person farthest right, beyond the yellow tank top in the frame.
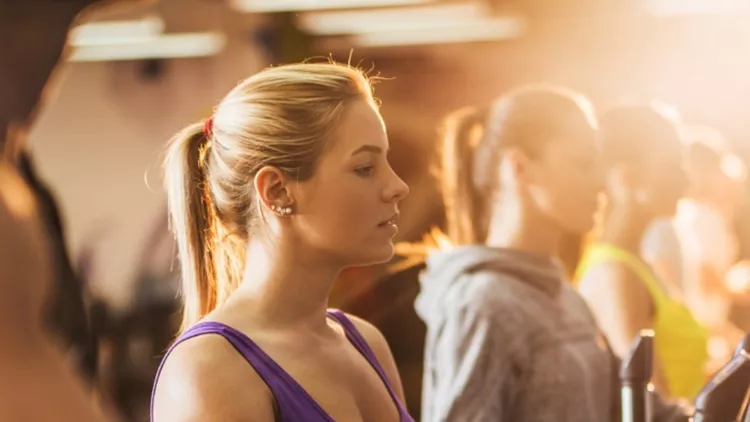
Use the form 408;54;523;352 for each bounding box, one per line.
642;128;745;363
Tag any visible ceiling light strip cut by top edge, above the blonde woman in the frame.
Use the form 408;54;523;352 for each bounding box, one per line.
231;0;431;13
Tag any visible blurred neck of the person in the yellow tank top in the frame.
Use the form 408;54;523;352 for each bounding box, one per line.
599;206;651;255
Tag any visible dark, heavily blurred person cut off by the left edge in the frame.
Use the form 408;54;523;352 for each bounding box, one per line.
0;0;151;422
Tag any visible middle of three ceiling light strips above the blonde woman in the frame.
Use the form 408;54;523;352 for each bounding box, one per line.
297;3;488;35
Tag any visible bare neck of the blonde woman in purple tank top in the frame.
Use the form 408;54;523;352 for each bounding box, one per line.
233;241;342;333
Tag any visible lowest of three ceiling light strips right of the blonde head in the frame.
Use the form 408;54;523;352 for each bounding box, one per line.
352;18;525;47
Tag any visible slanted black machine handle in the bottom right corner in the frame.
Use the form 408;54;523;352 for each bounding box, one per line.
693;335;750;422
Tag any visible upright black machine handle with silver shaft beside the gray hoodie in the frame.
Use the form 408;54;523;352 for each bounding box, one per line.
620;330;654;422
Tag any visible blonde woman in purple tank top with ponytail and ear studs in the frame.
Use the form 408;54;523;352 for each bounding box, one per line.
152;63;412;422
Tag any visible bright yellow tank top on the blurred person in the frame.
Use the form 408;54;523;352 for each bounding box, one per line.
575;244;709;399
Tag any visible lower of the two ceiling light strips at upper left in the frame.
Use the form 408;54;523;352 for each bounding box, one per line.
69;32;227;62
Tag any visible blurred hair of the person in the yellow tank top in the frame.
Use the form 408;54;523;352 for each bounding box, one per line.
599;104;682;166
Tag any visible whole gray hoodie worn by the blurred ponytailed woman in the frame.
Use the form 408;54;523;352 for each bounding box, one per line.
415;246;688;422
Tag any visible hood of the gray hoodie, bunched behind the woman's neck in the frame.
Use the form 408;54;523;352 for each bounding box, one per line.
414;245;564;322
